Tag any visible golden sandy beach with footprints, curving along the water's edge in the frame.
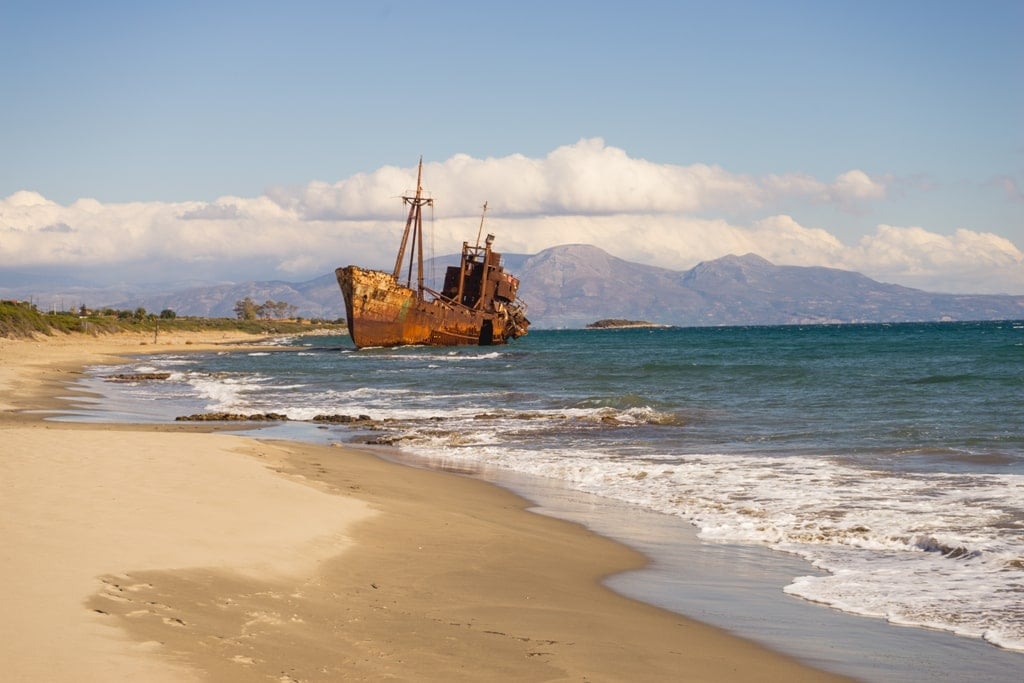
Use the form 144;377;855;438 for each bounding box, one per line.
0;333;848;682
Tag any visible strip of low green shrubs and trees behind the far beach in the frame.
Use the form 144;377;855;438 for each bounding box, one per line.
0;301;344;339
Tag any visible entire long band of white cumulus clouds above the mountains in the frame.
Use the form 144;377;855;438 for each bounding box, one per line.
0;138;1024;292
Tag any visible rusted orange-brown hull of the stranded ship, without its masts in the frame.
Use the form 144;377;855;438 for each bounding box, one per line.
335;265;529;348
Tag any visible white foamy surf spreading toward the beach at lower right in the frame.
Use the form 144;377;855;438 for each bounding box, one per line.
393;437;1024;649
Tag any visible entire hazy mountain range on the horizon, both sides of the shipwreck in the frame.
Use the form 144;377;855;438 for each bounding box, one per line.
0;245;1024;329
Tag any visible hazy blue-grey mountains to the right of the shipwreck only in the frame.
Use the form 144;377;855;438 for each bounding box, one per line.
514;245;1024;328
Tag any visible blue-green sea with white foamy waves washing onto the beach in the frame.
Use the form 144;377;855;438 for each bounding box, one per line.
61;322;1024;682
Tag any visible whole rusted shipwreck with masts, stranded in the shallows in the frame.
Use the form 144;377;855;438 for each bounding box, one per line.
335;159;529;348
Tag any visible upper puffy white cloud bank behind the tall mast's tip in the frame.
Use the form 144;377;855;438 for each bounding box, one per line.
268;138;886;220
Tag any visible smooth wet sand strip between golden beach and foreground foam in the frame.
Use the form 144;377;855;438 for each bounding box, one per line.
479;472;1022;683
